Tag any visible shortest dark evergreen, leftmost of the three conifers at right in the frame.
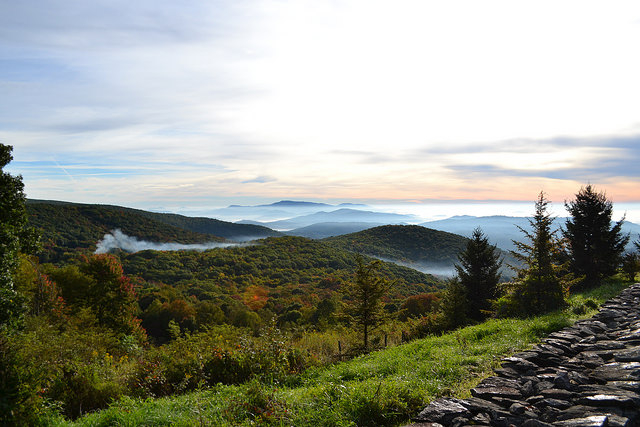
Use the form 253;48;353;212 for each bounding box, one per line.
455;228;502;321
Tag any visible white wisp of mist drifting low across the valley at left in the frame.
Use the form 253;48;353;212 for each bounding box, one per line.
95;229;240;254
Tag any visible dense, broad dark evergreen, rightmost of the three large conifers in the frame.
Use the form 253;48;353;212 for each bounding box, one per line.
563;185;629;288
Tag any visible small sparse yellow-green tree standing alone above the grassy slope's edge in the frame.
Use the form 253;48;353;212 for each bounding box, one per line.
344;258;393;350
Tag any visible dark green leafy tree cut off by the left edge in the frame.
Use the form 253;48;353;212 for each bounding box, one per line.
0;144;37;330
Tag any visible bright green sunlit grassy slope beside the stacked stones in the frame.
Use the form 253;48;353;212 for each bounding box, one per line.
60;282;627;426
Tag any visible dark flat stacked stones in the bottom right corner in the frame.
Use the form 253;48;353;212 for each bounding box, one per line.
411;284;640;427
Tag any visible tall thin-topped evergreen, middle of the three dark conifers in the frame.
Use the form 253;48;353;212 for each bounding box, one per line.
511;192;569;315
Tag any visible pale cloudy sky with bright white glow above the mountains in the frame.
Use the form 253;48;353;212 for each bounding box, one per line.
0;0;640;214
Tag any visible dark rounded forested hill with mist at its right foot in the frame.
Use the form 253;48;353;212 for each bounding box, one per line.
324;225;468;265
